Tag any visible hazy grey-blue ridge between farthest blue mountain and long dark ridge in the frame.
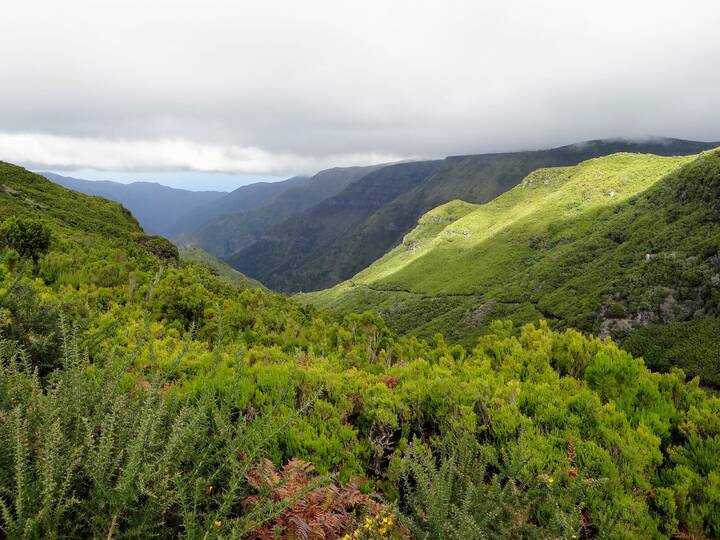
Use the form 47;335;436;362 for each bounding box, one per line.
183;165;383;257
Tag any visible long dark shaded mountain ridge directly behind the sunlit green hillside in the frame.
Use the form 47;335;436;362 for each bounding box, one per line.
227;139;716;292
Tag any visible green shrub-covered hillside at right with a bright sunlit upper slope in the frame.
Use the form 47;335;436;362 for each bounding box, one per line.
304;150;720;386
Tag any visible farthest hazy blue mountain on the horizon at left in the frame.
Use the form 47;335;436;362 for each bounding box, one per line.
39;172;226;236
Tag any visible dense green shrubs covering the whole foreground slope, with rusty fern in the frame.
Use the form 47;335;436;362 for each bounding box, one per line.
0;164;720;538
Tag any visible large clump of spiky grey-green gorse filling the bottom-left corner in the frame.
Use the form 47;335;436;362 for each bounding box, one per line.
0;318;312;538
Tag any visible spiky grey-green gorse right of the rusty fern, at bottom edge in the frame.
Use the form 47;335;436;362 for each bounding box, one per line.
404;436;583;540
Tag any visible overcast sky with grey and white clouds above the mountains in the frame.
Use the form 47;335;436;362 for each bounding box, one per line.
0;0;720;189
